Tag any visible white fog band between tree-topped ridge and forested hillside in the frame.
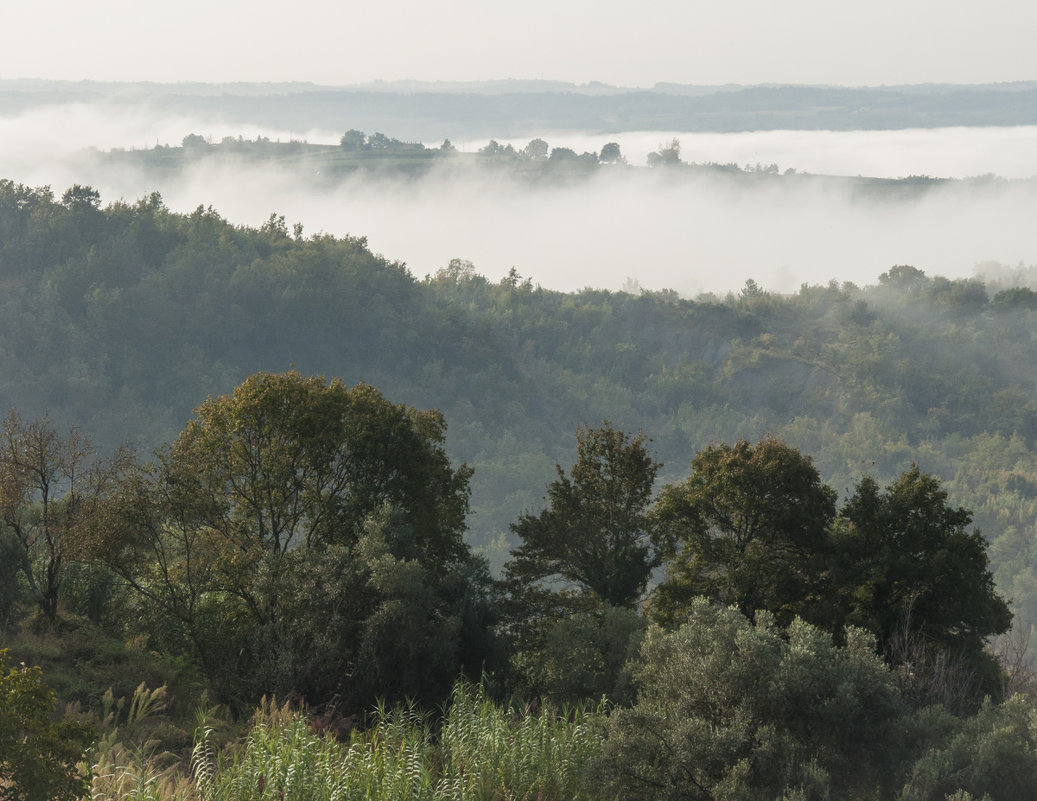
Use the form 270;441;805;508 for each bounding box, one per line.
3;137;1037;296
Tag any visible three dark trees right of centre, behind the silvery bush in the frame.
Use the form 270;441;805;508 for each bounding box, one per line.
504;425;1012;706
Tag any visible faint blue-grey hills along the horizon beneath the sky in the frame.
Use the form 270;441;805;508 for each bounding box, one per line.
0;81;1037;139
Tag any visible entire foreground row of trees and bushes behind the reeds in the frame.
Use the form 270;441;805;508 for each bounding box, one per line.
0;371;1020;799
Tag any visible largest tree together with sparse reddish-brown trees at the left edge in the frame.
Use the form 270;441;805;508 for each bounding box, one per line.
0;372;492;711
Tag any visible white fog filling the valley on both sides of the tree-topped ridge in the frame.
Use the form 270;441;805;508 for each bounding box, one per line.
0;107;1037;295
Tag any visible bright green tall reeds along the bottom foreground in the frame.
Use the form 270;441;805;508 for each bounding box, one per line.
87;683;598;801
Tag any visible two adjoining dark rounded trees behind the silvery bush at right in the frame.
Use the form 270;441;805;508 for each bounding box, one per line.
650;438;1011;710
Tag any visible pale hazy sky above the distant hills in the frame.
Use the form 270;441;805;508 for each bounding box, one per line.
6;0;1037;86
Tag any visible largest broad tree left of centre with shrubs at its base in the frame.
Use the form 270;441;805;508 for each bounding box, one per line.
91;371;489;707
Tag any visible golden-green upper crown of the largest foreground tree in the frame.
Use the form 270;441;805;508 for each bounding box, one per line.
168;371;471;568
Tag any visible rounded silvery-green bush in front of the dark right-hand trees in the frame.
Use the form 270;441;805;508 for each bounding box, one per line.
598;599;905;800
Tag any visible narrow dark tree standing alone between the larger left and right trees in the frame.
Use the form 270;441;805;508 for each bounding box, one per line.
502;422;660;698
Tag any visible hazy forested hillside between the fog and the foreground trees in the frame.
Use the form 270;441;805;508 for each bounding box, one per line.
6;182;1037;619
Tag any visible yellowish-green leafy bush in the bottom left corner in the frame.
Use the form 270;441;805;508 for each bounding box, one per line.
0;650;92;801
